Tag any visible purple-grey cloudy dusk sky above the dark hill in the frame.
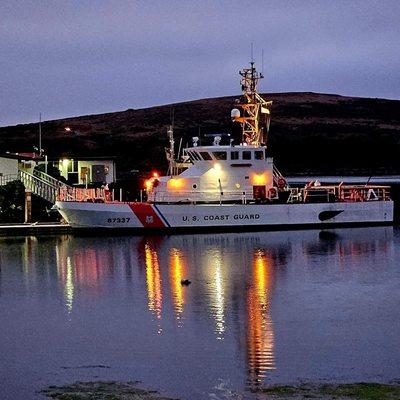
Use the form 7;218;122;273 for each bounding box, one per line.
0;0;400;126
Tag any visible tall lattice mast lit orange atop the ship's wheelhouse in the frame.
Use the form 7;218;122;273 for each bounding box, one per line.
235;60;272;146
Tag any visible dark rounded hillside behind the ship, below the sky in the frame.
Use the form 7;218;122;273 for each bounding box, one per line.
0;93;400;174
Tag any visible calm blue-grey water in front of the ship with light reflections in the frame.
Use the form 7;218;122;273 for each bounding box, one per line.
0;227;400;399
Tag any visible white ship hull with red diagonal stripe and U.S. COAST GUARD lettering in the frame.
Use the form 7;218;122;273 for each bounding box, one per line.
56;201;393;231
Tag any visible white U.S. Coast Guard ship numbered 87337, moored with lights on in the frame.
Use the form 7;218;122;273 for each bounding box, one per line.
55;61;394;232
